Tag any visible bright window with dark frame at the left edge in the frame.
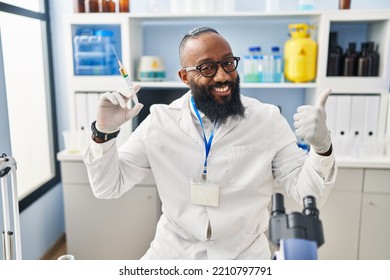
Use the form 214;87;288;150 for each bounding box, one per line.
0;0;59;211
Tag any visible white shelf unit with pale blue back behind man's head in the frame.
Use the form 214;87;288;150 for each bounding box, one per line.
64;10;390;154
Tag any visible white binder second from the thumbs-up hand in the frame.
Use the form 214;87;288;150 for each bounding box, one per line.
349;95;366;156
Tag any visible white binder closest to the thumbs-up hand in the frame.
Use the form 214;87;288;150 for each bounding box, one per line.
334;94;352;155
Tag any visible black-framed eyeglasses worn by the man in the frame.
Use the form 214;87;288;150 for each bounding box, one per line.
183;56;240;78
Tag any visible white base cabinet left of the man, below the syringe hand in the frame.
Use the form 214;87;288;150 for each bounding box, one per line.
58;152;161;260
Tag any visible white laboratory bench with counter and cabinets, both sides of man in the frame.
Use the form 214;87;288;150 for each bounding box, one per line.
57;151;390;260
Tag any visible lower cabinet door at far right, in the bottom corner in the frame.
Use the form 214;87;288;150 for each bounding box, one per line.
359;193;390;260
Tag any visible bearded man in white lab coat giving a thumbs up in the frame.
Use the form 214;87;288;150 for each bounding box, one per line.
84;27;336;259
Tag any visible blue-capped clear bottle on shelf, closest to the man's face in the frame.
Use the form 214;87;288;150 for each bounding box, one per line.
243;46;262;83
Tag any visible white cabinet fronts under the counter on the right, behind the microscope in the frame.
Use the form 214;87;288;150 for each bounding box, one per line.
272;167;390;260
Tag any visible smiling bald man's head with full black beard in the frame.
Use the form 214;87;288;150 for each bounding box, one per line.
179;33;244;123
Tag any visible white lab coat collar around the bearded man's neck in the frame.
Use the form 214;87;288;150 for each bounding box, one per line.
169;91;248;146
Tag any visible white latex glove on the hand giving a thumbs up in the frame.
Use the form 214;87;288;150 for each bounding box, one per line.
294;89;332;154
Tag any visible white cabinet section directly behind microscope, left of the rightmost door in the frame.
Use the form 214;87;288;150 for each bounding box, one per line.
275;168;363;260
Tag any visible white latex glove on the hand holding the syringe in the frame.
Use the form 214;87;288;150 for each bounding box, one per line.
96;85;144;133
